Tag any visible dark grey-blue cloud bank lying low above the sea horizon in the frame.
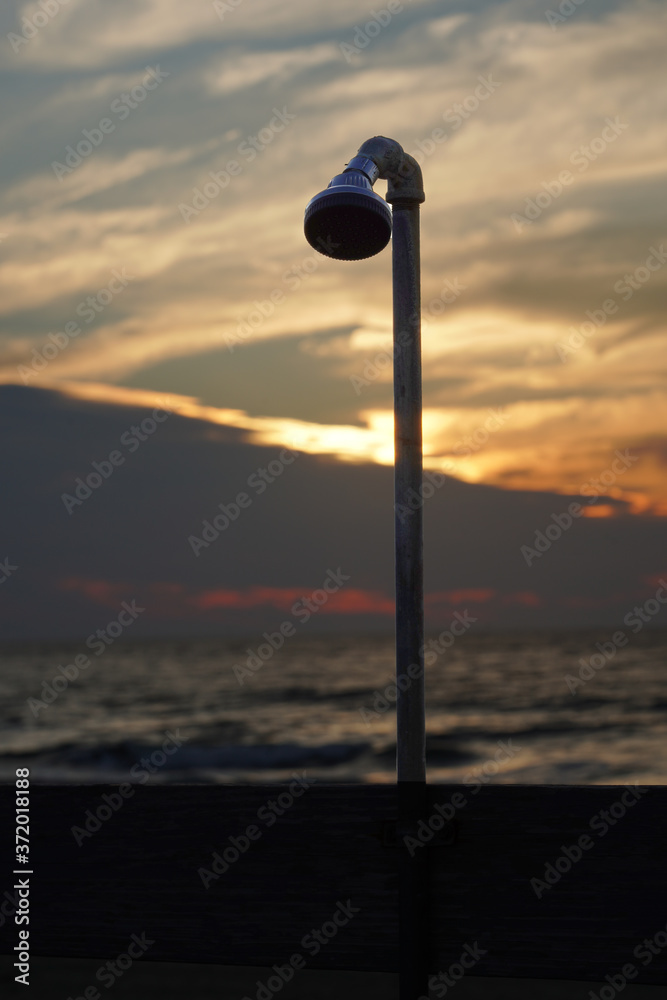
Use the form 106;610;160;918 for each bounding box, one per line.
0;387;667;639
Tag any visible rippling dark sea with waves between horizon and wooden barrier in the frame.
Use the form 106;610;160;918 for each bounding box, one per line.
5;630;667;785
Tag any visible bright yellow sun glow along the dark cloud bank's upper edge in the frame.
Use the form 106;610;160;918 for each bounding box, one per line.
7;381;656;518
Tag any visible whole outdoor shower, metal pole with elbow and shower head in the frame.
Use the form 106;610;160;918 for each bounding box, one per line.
306;136;429;1000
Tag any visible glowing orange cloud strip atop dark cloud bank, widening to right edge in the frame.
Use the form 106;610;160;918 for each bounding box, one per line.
14;382;667;518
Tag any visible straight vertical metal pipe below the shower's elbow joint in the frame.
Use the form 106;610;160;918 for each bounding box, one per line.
392;191;429;1000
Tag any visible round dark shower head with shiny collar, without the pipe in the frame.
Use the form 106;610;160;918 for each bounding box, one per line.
304;170;392;260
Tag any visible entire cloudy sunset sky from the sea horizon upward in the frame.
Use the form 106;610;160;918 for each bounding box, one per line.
0;0;667;638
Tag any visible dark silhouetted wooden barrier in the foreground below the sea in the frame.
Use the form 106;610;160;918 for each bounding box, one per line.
5;784;667;984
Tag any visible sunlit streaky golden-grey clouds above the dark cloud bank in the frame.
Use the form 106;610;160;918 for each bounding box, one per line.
0;0;667;540
